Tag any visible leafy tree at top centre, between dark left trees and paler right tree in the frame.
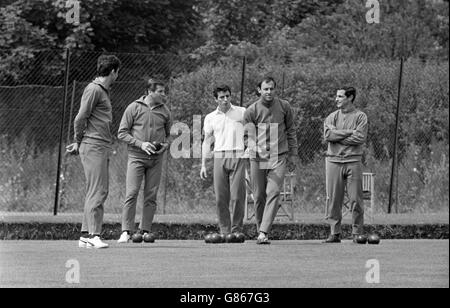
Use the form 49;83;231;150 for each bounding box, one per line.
192;0;342;59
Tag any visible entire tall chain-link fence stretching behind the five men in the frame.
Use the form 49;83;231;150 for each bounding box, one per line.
0;51;449;217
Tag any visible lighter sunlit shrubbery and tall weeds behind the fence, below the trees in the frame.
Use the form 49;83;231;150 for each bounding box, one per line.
1;57;449;213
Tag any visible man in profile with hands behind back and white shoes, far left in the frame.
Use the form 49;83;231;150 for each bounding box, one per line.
67;55;120;248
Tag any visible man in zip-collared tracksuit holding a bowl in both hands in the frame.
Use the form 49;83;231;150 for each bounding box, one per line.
118;79;172;243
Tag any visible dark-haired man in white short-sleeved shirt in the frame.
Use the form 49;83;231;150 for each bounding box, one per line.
200;85;246;239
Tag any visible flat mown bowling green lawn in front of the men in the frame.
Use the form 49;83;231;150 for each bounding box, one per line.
0;240;449;288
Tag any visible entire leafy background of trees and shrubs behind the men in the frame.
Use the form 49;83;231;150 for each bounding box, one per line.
0;0;449;213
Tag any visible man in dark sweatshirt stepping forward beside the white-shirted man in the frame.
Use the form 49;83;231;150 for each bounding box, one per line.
244;77;298;244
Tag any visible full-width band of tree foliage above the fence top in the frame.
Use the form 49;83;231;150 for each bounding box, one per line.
0;0;449;84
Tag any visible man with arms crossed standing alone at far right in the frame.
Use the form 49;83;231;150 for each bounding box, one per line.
324;87;367;243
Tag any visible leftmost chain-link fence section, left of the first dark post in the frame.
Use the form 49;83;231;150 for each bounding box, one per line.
0;50;64;211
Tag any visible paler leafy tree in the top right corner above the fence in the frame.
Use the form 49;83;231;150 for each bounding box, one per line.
293;0;448;59
